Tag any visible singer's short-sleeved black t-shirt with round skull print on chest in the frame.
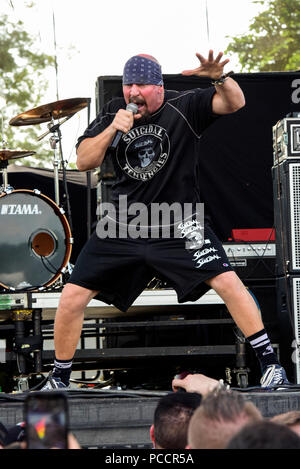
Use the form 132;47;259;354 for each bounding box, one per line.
77;87;217;227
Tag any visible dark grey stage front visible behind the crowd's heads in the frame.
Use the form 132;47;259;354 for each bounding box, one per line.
0;386;300;449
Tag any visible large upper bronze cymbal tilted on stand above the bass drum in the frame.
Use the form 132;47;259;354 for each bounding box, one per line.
9;98;90;125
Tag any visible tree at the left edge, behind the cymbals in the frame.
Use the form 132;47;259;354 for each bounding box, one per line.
0;11;54;166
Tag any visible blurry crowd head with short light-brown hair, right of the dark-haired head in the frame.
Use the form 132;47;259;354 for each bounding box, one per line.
188;391;262;449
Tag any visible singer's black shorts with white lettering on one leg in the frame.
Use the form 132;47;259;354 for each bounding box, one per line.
68;226;233;311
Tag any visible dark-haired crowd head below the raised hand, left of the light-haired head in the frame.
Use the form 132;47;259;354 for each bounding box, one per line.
150;392;202;449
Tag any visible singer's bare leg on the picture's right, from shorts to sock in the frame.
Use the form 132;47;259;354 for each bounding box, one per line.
206;272;264;337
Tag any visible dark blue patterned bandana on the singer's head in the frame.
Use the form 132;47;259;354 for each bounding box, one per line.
123;55;163;85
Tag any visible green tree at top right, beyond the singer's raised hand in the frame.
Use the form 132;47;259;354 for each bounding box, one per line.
226;0;300;72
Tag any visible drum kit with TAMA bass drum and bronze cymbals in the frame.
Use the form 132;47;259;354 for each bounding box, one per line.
0;98;90;292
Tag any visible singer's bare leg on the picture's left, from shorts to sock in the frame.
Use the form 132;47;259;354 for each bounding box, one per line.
54;283;98;360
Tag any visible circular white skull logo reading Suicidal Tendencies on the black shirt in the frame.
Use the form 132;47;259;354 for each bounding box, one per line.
117;124;170;181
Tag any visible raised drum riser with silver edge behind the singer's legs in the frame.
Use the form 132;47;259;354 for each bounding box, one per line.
0;282;294;393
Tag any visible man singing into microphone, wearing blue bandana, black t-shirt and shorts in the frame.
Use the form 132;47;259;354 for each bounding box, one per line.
43;50;288;389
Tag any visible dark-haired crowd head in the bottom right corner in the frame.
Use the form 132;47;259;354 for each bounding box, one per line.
226;420;300;449
